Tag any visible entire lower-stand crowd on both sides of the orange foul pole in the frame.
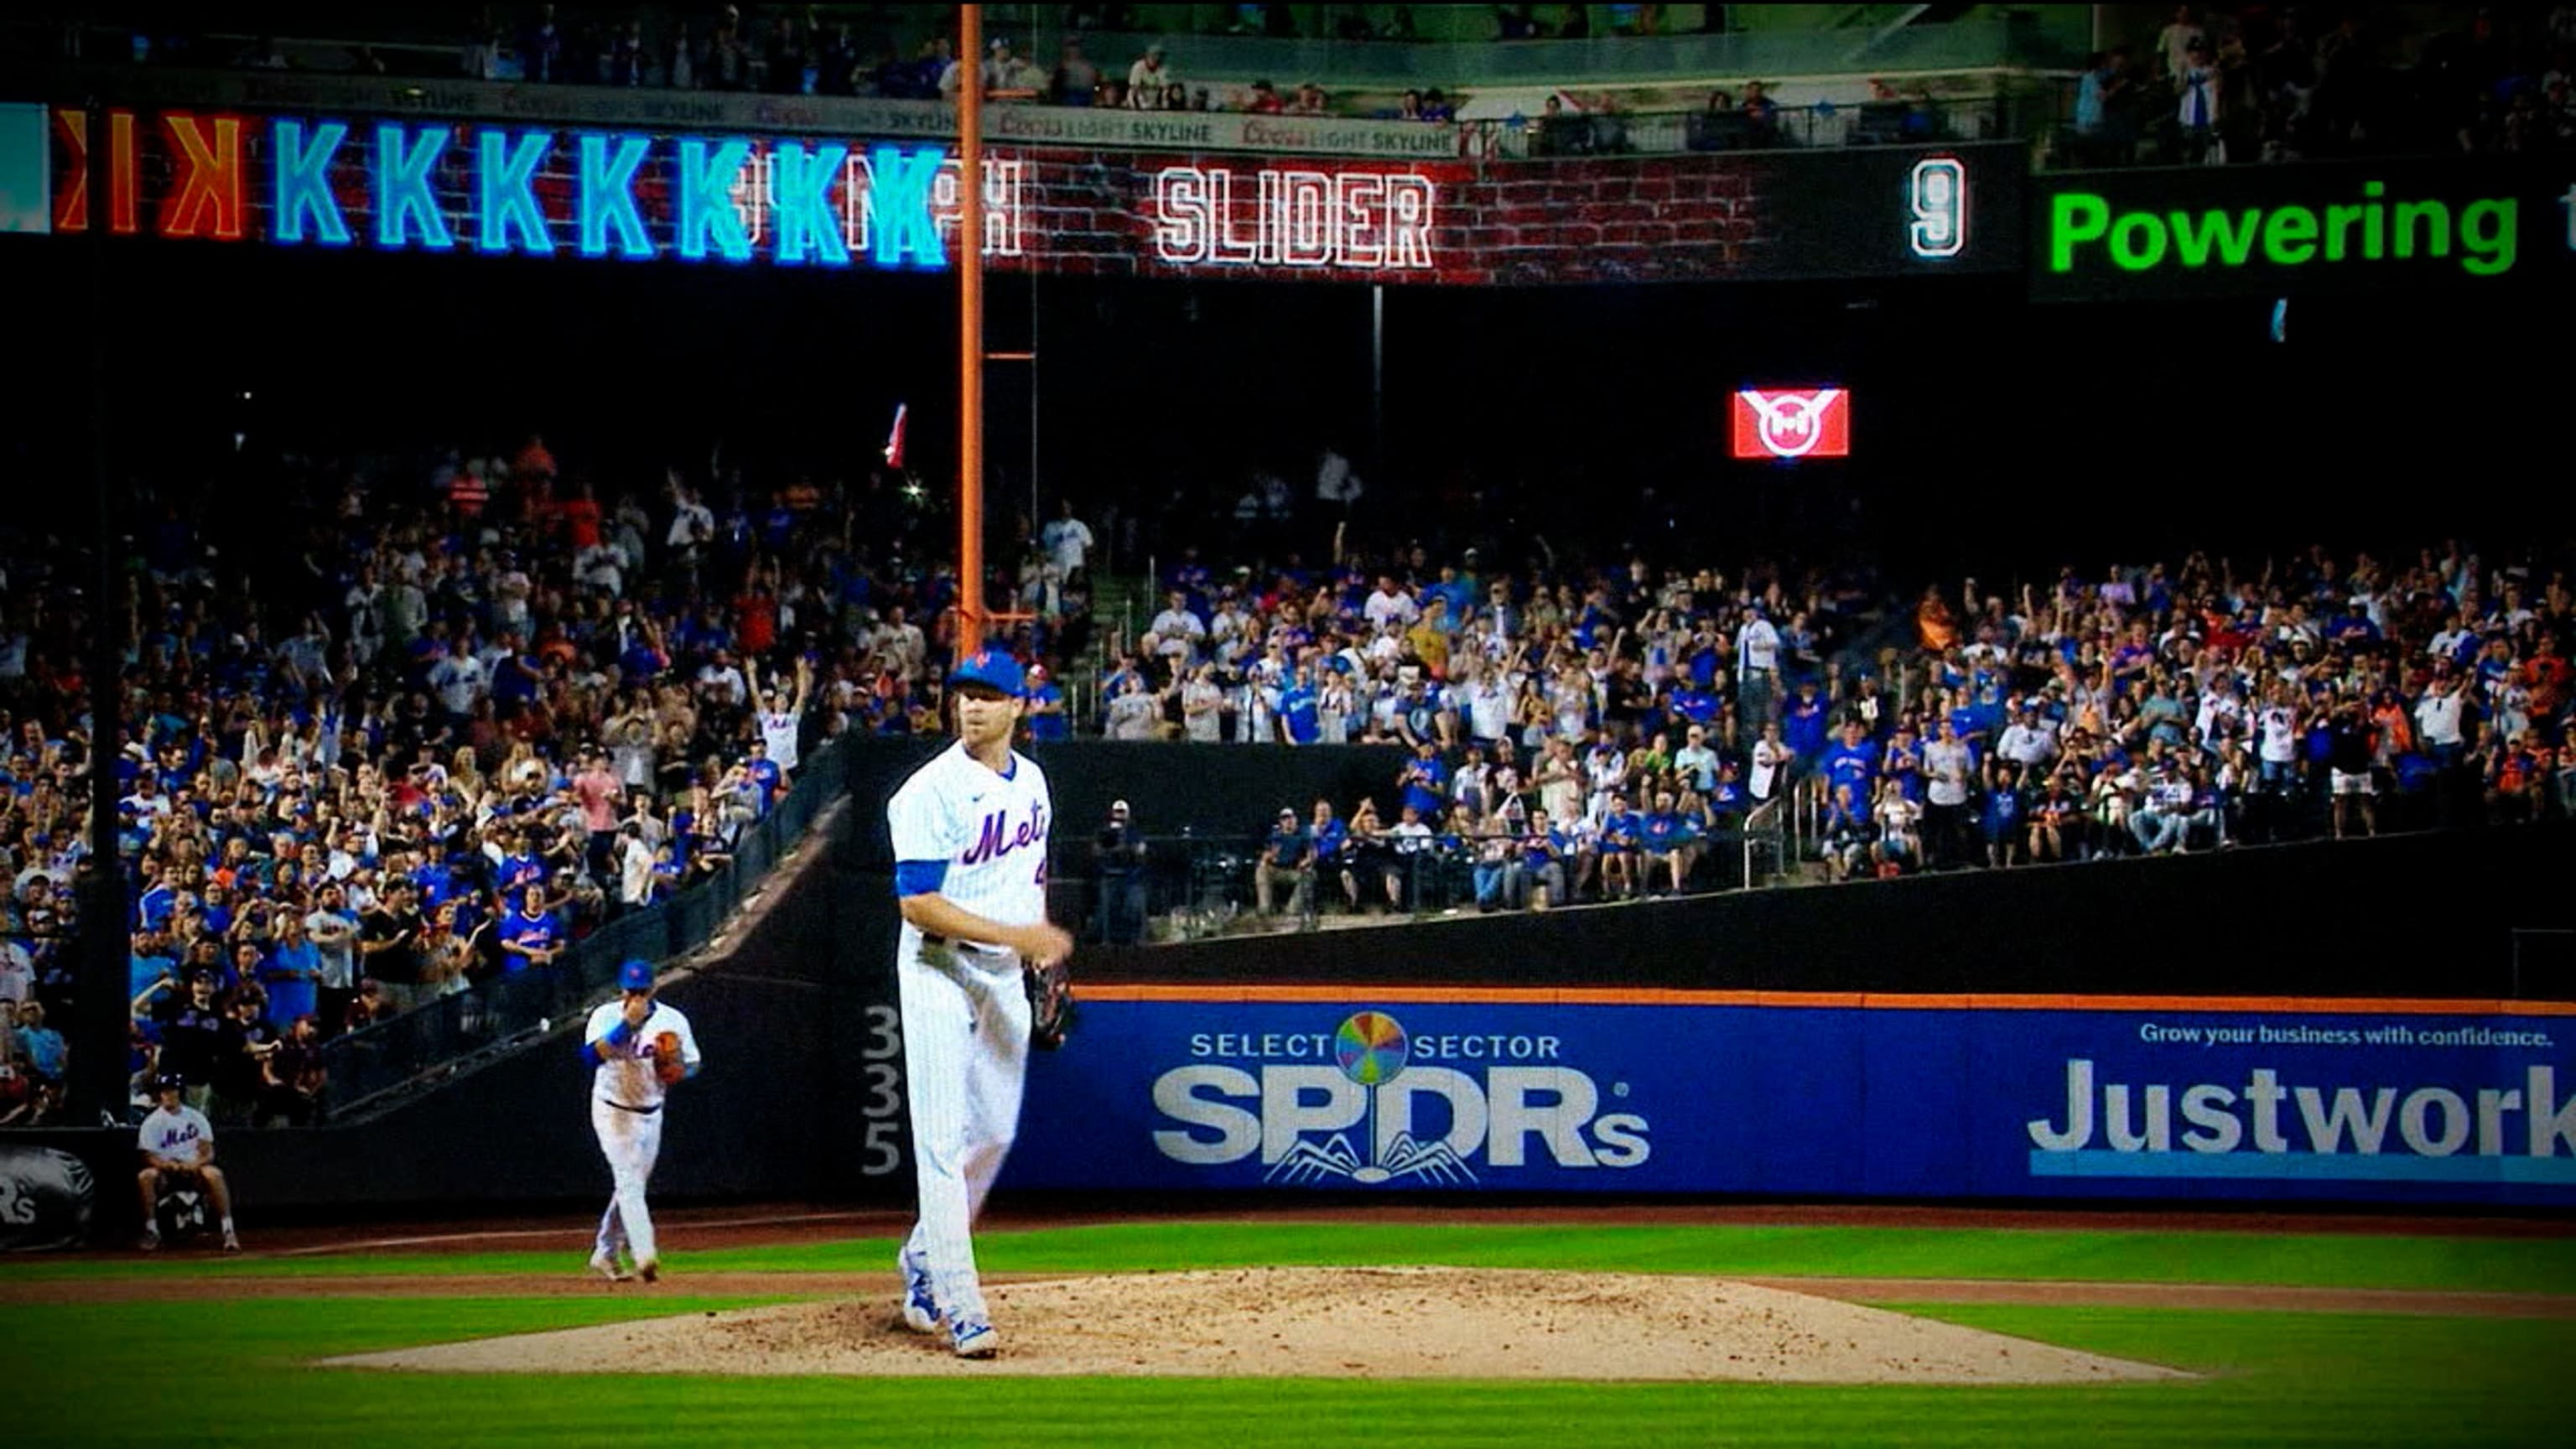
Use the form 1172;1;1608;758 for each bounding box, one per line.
0;415;2576;1103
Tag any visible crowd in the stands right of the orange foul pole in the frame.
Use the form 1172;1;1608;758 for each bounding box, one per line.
1103;531;2576;912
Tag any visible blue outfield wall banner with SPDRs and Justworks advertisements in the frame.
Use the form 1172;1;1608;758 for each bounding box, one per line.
1005;995;2576;1207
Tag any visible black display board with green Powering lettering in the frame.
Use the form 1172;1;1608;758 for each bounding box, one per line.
2033;160;2576;299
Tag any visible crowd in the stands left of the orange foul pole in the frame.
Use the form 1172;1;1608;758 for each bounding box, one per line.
0;439;1082;1122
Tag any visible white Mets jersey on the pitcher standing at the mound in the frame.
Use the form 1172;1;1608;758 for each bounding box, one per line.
886;743;1057;949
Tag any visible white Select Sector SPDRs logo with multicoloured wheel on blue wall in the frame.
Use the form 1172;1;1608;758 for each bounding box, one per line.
1154;1010;1651;1186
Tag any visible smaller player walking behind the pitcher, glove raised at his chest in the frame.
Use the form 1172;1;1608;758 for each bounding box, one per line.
582;962;701;1284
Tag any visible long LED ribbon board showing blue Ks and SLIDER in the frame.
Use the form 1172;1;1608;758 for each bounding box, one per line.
0;103;2023;286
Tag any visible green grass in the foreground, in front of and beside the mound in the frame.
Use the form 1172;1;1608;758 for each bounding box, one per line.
8;1295;2576;1449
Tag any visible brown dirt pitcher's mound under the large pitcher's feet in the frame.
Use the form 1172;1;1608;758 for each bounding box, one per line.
330;1269;2189;1384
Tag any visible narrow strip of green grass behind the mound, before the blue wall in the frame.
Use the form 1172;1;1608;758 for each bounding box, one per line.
15;1222;2576;1295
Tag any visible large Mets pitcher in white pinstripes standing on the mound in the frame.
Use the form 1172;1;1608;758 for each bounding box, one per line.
886;650;1074;1358
